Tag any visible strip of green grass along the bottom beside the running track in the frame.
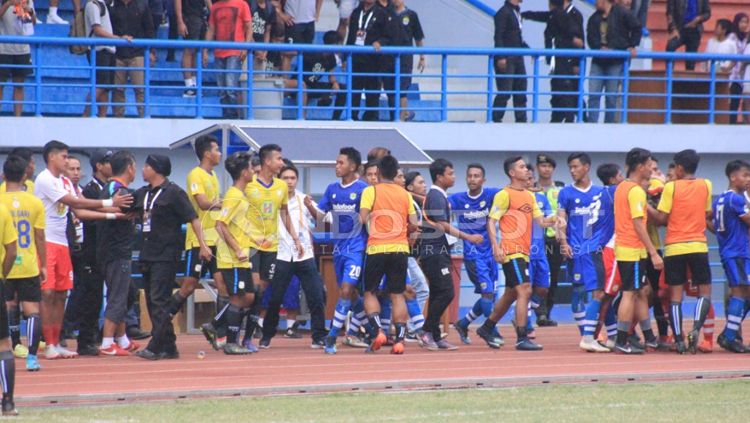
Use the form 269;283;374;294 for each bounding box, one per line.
19;380;750;423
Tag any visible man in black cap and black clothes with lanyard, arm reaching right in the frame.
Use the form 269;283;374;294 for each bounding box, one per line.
134;154;211;360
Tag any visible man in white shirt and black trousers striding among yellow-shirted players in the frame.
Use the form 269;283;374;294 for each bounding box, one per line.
260;165;328;348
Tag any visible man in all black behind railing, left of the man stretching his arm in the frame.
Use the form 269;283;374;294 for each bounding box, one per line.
492;0;528;122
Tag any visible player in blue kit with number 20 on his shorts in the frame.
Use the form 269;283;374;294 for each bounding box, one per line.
308;147;367;354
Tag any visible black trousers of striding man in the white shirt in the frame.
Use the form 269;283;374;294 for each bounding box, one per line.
263;258;328;341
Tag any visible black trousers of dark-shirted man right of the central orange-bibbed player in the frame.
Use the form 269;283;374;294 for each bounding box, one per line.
419;254;455;341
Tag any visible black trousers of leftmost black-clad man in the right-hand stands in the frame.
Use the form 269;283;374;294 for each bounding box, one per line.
492;57;527;122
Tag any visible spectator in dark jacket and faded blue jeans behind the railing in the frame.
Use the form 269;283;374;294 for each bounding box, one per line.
586;0;641;123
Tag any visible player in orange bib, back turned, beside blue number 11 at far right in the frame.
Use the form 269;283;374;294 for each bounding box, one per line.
654;149;712;354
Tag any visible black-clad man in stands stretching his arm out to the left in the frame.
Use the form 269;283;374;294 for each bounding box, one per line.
521;0;584;123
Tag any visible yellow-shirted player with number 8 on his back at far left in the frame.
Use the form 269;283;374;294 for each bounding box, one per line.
0;155;47;372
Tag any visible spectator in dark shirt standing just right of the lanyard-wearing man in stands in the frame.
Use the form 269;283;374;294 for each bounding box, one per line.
381;0;425;121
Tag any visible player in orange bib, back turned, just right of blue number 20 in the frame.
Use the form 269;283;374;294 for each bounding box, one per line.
359;156;417;354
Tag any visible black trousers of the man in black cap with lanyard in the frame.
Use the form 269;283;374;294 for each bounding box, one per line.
141;261;178;354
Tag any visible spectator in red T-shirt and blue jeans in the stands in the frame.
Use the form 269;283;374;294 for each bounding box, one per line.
203;0;253;119
